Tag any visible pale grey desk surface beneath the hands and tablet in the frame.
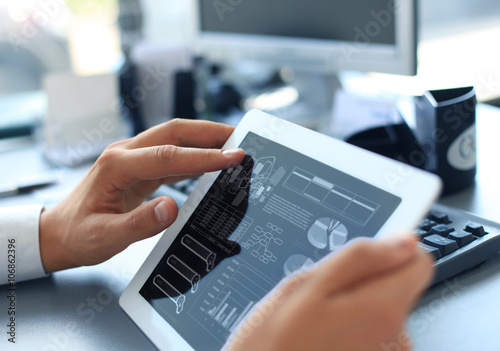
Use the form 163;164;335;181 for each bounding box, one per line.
0;106;500;351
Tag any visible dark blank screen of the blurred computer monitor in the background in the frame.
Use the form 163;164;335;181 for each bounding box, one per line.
199;0;398;45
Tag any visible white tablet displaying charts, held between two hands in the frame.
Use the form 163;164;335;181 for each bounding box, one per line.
120;110;441;351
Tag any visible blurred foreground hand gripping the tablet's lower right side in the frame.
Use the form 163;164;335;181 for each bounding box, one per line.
225;235;432;351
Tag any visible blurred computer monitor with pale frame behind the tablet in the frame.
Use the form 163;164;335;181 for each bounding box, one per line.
188;0;417;125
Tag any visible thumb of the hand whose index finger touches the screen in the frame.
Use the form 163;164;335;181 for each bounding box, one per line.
115;196;178;244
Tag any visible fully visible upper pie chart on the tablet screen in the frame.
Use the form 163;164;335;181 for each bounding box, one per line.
307;217;349;251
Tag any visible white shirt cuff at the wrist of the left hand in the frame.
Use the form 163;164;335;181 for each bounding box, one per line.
0;205;48;285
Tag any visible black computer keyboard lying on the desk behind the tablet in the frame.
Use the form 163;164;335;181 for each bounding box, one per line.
154;178;500;285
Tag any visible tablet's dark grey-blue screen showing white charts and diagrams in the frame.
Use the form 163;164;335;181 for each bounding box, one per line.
140;133;401;350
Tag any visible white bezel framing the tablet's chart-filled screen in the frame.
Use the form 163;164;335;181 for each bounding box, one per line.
119;110;442;350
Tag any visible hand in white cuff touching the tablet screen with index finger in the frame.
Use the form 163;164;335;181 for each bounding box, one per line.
40;119;244;272
